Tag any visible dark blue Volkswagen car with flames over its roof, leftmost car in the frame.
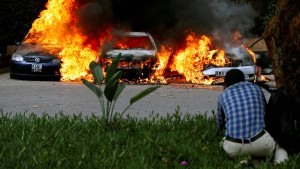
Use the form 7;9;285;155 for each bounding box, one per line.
10;43;61;81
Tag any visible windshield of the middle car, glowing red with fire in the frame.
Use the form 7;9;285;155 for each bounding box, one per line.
113;36;154;50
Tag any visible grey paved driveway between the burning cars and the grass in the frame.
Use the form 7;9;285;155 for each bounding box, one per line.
0;73;222;117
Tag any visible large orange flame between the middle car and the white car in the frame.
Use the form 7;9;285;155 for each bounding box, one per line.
155;32;228;84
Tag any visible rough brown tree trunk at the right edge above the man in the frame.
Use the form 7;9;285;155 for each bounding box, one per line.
263;0;300;97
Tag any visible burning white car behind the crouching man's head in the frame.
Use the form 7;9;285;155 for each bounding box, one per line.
202;47;256;83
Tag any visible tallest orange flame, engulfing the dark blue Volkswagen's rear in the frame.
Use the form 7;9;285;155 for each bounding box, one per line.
24;0;109;81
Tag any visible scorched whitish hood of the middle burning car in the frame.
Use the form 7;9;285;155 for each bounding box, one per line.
106;49;156;60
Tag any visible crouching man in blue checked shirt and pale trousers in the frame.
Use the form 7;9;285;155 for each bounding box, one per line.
216;69;288;163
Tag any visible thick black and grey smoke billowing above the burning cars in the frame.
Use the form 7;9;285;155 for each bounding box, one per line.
77;0;255;48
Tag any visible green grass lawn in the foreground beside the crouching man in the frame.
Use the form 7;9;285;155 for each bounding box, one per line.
0;110;300;169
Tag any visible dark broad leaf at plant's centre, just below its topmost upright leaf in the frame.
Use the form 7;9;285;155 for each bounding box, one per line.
104;71;122;101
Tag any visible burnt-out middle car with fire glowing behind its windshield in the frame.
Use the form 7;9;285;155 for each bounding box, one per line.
99;32;157;80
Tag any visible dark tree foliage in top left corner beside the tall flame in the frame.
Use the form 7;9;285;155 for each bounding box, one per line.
0;0;48;54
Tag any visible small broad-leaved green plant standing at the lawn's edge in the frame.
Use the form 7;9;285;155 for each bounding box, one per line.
81;55;160;123
